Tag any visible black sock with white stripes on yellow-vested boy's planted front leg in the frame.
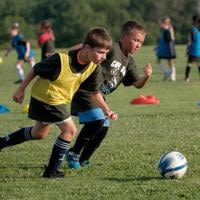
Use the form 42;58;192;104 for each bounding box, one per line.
48;137;70;171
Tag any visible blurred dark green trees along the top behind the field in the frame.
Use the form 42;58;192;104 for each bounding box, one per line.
0;0;200;48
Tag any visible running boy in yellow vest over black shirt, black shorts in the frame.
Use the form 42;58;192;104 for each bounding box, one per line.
0;28;117;178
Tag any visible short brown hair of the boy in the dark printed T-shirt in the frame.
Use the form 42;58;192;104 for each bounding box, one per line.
121;21;146;35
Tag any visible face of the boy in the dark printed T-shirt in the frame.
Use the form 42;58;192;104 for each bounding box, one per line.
120;30;146;55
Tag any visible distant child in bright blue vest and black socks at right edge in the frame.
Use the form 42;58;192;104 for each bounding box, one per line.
185;15;200;82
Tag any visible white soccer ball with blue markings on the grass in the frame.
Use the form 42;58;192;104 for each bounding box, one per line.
158;151;188;179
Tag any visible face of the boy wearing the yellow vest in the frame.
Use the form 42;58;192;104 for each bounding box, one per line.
88;47;109;64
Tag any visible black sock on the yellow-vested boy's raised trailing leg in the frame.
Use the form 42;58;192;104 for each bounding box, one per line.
0;127;33;149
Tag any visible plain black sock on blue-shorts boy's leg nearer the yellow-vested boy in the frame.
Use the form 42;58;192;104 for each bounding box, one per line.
70;120;104;154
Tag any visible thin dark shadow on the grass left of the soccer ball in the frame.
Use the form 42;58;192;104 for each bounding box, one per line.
102;176;164;183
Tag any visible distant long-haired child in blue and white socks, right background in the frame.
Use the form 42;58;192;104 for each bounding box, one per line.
156;16;176;81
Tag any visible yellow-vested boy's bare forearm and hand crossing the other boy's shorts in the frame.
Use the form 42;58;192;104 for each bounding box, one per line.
91;92;118;120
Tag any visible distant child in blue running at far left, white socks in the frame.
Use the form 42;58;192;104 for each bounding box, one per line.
5;23;35;84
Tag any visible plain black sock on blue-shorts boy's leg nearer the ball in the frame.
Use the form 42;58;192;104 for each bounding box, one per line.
80;127;109;163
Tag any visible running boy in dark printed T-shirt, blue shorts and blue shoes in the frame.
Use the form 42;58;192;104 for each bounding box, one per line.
67;21;152;169
